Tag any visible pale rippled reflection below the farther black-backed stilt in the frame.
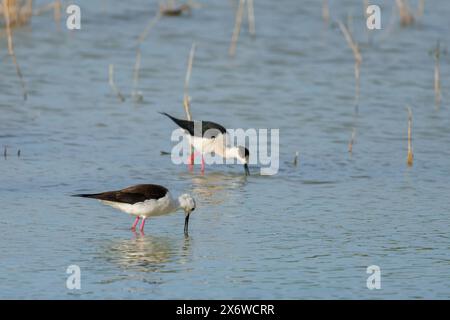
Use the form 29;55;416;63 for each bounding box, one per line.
185;172;247;205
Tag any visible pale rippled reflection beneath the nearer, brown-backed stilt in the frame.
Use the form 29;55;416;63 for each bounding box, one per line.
104;234;176;272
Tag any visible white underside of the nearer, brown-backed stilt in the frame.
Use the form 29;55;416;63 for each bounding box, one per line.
102;193;176;217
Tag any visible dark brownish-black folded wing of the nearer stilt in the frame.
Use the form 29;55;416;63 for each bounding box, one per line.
74;184;169;204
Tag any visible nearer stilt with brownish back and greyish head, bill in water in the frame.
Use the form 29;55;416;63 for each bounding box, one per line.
73;184;195;235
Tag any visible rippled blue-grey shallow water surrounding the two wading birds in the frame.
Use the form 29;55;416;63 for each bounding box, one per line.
0;0;450;299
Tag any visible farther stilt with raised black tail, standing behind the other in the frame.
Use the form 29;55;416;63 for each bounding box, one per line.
160;112;250;175
